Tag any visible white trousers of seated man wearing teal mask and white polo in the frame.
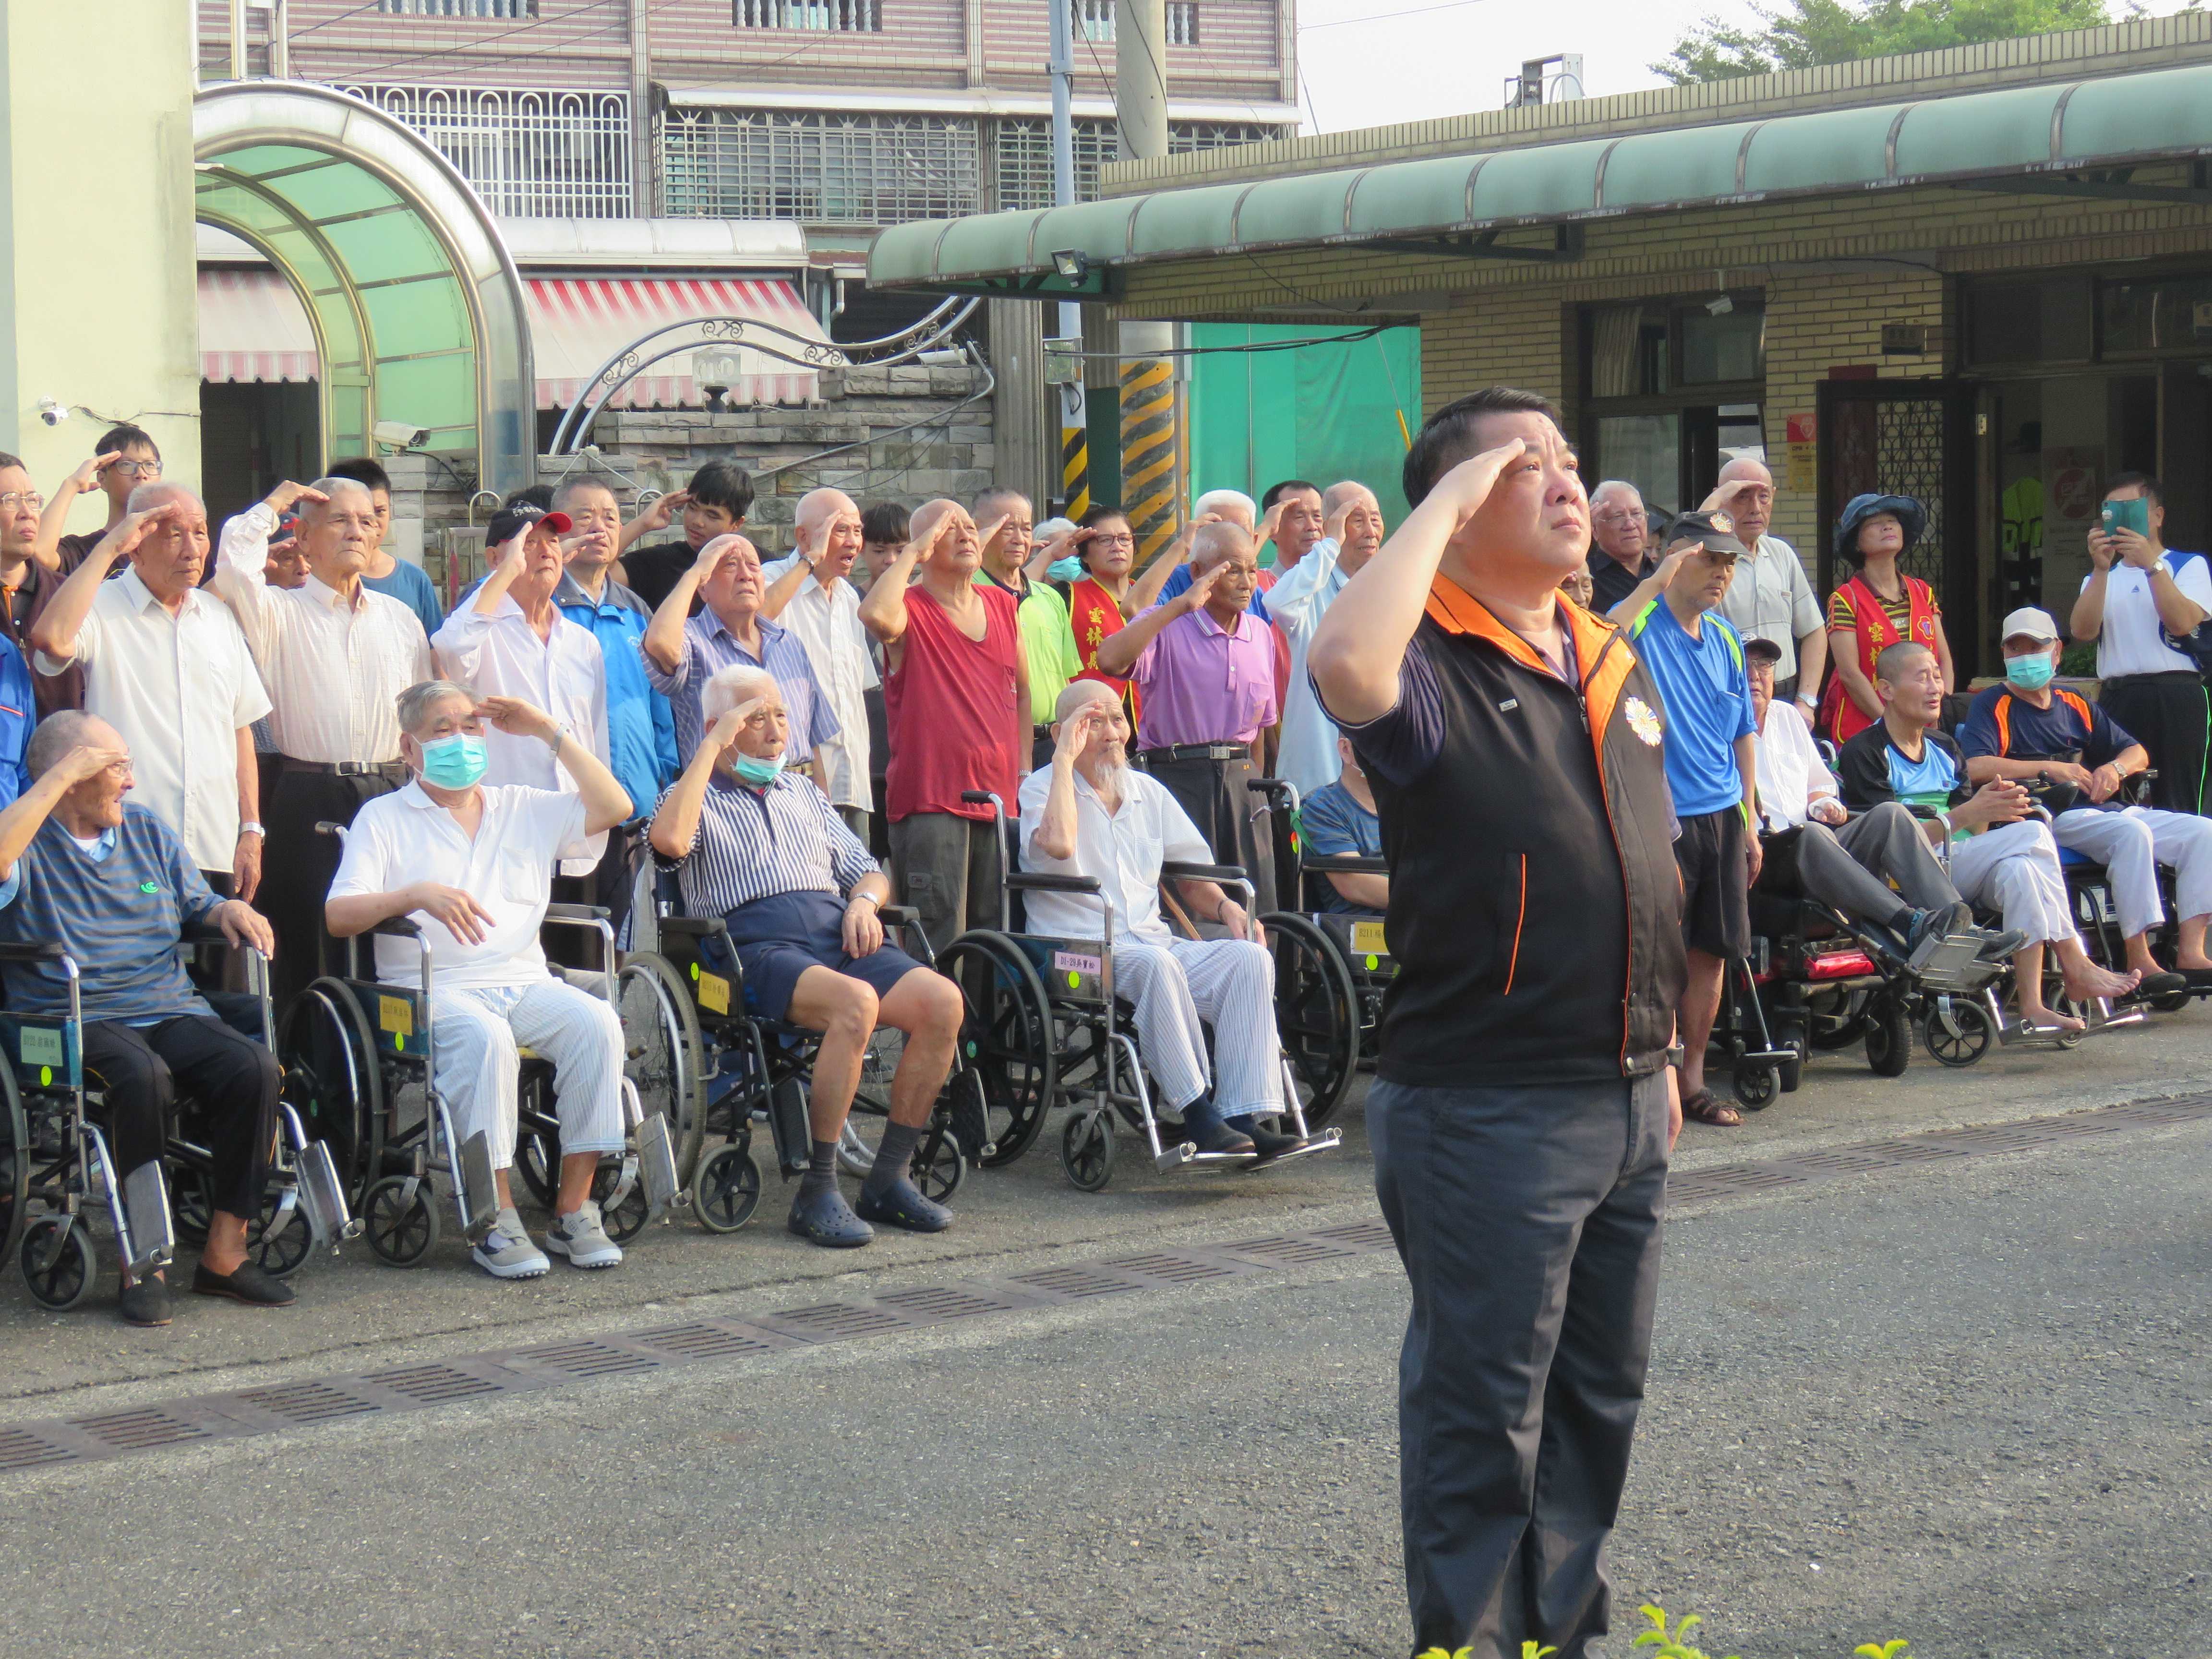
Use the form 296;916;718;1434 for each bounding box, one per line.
432;978;624;1170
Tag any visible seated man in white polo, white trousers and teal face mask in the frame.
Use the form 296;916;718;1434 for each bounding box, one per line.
323;679;630;1278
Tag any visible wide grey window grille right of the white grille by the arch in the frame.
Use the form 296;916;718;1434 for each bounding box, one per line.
661;108;982;226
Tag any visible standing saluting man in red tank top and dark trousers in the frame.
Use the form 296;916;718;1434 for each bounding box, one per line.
861;500;1029;951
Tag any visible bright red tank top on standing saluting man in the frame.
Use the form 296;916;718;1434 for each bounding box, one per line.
883;584;1029;823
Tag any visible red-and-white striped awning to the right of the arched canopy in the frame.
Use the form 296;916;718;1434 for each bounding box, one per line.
527;276;830;409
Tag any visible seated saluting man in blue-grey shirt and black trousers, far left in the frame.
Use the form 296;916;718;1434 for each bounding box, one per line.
0;710;292;1325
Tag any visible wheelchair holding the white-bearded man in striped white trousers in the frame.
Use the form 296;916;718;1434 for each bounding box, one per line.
942;792;1358;1192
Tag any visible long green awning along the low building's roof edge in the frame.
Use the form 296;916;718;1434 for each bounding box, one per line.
867;66;2212;299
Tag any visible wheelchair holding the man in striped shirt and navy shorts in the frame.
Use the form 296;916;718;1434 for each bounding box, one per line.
655;887;991;1232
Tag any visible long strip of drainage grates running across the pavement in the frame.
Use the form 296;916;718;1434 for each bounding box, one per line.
0;1093;2212;1476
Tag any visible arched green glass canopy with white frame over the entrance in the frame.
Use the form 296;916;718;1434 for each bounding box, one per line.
192;82;538;493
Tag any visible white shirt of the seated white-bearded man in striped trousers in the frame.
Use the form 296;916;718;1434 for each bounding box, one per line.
1020;761;1212;938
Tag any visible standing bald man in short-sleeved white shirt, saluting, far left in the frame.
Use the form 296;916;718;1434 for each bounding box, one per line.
31;484;270;898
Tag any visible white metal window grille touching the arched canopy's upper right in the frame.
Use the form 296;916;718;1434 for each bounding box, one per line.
345;87;635;219
